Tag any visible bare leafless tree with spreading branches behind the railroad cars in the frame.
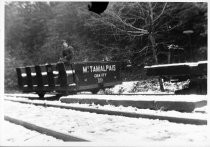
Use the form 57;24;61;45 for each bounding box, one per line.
86;2;167;91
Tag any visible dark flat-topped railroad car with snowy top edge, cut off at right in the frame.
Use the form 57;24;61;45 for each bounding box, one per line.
144;61;207;95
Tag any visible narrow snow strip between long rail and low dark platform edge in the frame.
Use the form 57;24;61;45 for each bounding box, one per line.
4;95;207;119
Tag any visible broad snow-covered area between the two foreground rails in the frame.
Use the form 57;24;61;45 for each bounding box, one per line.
4;101;207;145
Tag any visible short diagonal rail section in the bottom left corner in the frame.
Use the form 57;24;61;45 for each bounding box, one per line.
4;115;88;142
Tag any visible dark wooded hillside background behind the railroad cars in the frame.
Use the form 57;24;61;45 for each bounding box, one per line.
5;2;207;90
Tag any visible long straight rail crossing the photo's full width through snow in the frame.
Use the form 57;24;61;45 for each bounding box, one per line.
5;95;207;125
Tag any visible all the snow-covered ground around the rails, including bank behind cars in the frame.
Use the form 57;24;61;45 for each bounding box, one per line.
1;80;210;146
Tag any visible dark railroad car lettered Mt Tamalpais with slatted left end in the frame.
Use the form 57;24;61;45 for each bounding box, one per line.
16;61;122;98
